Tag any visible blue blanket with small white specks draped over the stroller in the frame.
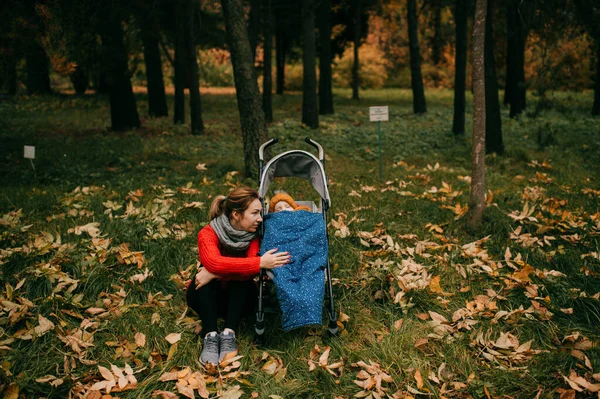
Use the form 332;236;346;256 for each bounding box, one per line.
260;211;328;331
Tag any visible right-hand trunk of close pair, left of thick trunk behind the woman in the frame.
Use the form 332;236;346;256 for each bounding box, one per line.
185;0;204;134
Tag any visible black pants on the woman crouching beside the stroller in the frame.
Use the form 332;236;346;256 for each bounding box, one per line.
186;280;257;334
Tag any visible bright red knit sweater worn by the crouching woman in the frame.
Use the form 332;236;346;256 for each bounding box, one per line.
198;224;260;280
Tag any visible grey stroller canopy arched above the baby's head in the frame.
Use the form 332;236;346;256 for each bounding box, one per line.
258;150;331;205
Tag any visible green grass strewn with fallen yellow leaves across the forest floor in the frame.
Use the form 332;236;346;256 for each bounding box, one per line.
0;90;600;398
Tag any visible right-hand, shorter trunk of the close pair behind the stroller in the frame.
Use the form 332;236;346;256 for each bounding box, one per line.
319;0;333;115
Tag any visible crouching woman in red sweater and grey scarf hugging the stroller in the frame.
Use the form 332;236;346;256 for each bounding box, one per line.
186;187;290;365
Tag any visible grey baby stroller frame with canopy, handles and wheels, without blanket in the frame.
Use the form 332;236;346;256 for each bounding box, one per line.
254;137;338;339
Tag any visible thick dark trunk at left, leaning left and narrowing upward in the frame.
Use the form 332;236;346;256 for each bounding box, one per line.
100;7;140;131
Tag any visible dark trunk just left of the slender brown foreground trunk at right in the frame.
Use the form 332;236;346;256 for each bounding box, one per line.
452;0;467;135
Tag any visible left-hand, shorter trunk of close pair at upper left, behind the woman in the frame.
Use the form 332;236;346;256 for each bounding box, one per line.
173;1;187;125
